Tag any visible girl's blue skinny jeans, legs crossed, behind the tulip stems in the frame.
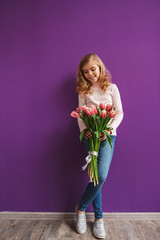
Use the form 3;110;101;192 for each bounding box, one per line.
78;135;116;219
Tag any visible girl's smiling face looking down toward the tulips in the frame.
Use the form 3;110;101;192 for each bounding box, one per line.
82;60;100;84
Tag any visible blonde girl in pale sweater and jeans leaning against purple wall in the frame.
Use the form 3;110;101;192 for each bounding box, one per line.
76;54;123;238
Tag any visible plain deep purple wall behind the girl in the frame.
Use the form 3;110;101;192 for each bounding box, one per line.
0;0;160;212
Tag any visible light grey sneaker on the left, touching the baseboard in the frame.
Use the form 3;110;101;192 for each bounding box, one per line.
75;206;87;234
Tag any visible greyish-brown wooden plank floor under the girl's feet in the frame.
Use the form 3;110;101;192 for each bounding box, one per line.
0;213;160;240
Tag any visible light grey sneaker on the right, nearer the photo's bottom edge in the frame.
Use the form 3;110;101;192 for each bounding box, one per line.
93;219;106;238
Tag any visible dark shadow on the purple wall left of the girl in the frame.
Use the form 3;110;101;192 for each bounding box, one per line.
50;76;87;212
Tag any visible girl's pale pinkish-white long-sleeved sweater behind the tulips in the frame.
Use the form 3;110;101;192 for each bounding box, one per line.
78;84;123;135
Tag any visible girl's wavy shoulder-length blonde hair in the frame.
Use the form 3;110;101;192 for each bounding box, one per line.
76;53;112;96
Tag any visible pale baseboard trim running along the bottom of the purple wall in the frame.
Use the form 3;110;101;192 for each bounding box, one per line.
0;212;160;220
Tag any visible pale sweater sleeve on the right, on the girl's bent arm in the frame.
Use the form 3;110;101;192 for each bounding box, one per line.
110;84;124;130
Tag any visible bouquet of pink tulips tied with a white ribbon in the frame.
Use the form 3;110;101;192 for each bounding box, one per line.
71;103;115;186
